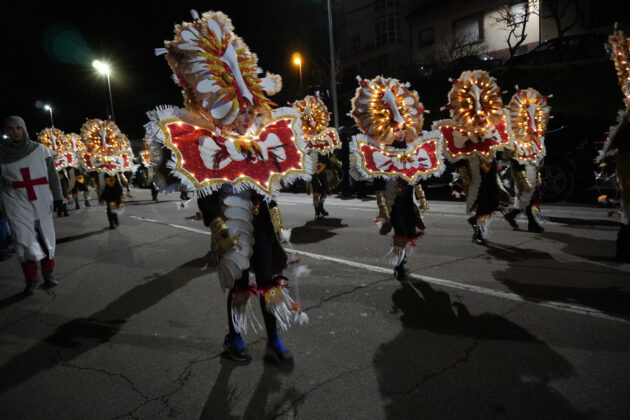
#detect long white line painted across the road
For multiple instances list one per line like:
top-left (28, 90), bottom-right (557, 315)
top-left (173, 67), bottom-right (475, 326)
top-left (130, 216), bottom-right (630, 324)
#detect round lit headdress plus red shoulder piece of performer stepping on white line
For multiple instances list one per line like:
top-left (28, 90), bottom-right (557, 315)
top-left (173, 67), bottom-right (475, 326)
top-left (350, 76), bottom-right (444, 183)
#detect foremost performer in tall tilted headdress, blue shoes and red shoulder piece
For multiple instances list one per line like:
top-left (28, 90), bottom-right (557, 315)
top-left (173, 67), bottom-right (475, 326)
top-left (145, 11), bottom-right (311, 363)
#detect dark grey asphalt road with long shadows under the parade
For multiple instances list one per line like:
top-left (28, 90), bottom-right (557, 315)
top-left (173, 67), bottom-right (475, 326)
top-left (0, 190), bottom-right (630, 419)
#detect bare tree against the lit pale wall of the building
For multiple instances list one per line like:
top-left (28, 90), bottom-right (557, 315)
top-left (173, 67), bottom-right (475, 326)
top-left (494, 0), bottom-right (537, 67)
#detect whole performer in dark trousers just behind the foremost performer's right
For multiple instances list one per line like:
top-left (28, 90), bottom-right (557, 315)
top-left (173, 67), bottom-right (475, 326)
top-left (292, 95), bottom-right (341, 219)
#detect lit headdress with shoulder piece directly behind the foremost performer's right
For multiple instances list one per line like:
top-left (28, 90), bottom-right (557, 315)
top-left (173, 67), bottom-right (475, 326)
top-left (291, 95), bottom-right (341, 154)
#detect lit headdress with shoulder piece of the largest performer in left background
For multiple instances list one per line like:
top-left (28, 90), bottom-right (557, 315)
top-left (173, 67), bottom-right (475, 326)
top-left (81, 119), bottom-right (133, 174)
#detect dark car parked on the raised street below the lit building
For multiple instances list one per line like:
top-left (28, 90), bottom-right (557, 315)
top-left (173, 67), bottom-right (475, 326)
top-left (513, 34), bottom-right (608, 65)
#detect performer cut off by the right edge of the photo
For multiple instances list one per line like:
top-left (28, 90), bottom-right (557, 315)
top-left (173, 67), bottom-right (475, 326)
top-left (595, 30), bottom-right (630, 262)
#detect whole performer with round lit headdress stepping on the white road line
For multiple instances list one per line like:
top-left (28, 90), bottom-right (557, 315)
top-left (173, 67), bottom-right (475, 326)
top-left (350, 76), bottom-right (445, 280)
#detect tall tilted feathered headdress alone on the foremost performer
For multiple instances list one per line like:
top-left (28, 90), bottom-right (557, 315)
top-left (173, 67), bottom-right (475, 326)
top-left (156, 10), bottom-right (282, 127)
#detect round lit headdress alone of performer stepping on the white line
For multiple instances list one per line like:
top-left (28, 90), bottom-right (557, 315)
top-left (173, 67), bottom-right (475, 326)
top-left (351, 76), bottom-right (425, 145)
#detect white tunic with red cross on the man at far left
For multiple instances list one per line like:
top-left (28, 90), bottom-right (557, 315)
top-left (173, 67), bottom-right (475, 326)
top-left (0, 144), bottom-right (55, 261)
